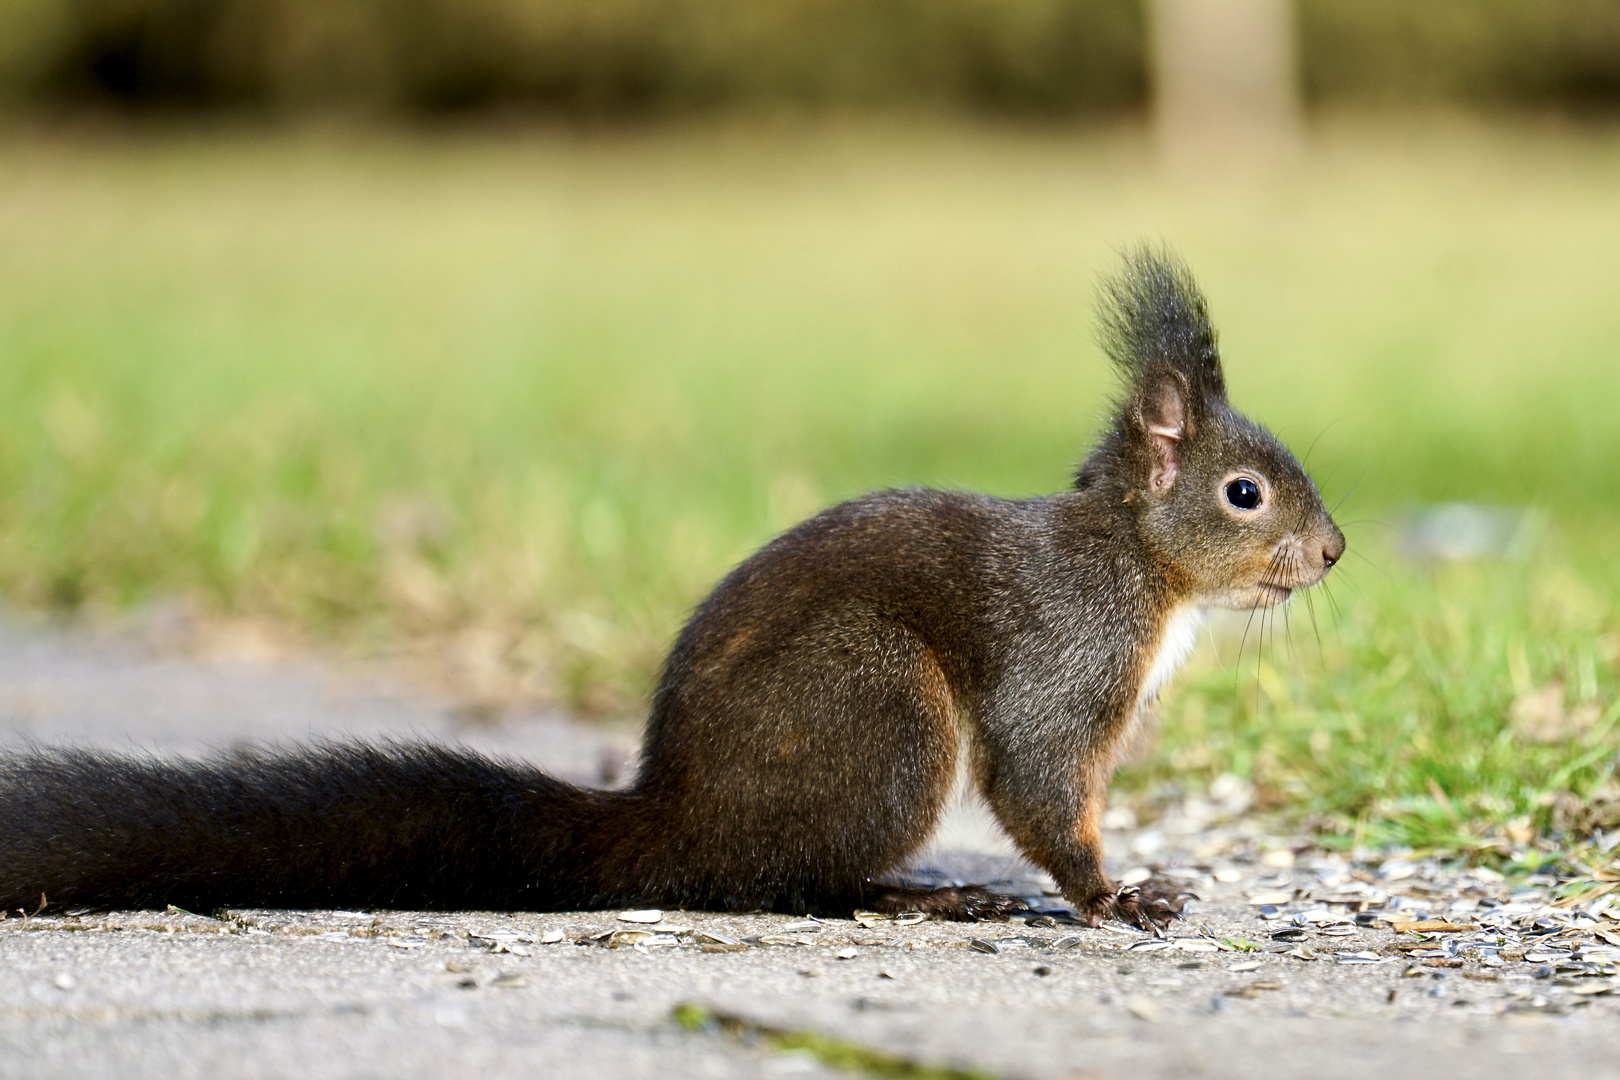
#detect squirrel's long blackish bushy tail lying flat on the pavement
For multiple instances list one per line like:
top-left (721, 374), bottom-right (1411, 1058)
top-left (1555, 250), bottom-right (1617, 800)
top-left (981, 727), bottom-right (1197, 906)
top-left (0, 743), bottom-right (632, 912)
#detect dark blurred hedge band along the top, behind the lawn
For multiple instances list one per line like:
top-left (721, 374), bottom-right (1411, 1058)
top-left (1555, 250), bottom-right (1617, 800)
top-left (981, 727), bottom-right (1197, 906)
top-left (0, 0), bottom-right (1620, 113)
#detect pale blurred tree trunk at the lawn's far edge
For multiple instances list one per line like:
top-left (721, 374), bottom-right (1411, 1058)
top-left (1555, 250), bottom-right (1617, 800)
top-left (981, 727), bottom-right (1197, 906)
top-left (1149, 0), bottom-right (1301, 165)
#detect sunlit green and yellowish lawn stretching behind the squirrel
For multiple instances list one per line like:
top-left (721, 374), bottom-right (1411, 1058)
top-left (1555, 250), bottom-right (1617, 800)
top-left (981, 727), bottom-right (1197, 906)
top-left (0, 120), bottom-right (1620, 867)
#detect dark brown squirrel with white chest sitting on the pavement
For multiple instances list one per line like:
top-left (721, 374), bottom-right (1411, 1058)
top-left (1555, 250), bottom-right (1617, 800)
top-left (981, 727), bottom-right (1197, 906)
top-left (0, 249), bottom-right (1345, 926)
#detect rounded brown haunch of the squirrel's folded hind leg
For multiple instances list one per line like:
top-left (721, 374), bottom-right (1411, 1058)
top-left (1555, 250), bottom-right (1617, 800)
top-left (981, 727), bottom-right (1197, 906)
top-left (625, 610), bottom-right (959, 918)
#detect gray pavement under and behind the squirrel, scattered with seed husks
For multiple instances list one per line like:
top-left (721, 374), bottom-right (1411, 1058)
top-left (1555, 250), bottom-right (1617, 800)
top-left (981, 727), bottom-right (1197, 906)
top-left (0, 628), bottom-right (1620, 1080)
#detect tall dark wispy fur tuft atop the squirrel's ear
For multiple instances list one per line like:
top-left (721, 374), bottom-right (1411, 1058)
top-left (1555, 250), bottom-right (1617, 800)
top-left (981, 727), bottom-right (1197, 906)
top-left (1098, 246), bottom-right (1226, 414)
